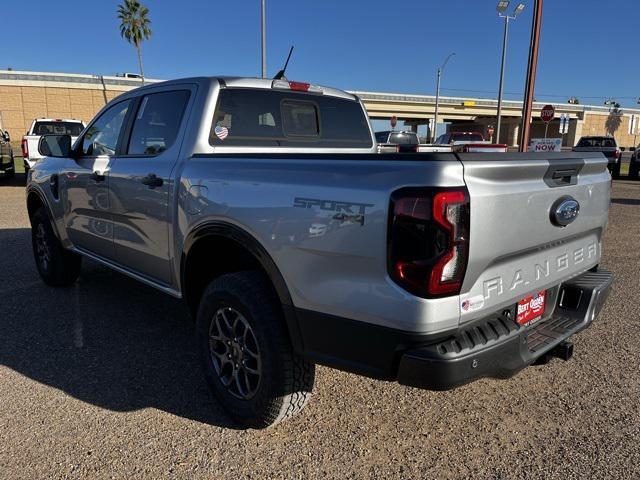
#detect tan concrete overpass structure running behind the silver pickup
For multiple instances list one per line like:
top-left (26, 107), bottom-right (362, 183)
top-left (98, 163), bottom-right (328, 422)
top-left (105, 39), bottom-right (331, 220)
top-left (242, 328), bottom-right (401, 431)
top-left (0, 70), bottom-right (640, 147)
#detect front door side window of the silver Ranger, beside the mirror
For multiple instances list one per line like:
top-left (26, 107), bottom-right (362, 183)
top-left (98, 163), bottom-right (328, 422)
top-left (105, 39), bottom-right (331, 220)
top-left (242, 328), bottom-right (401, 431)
top-left (82, 100), bottom-right (131, 157)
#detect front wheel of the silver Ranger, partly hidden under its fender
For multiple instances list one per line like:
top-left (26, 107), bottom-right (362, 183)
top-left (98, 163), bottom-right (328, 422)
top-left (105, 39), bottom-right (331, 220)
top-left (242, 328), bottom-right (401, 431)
top-left (31, 208), bottom-right (82, 287)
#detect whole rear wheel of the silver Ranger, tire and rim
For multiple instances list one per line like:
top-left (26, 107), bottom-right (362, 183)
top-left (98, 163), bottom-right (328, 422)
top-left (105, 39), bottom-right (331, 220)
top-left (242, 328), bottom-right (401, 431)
top-left (196, 271), bottom-right (315, 428)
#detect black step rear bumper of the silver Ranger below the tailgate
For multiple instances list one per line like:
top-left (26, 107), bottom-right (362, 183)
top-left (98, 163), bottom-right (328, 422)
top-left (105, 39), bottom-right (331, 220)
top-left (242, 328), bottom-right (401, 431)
top-left (397, 269), bottom-right (613, 390)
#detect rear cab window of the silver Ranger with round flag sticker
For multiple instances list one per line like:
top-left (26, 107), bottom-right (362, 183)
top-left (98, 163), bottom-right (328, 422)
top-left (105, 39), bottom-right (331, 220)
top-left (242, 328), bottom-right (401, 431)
top-left (209, 88), bottom-right (373, 148)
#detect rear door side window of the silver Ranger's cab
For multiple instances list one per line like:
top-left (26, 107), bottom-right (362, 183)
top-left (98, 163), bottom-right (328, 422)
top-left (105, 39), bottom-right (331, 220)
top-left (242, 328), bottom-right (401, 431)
top-left (127, 90), bottom-right (190, 155)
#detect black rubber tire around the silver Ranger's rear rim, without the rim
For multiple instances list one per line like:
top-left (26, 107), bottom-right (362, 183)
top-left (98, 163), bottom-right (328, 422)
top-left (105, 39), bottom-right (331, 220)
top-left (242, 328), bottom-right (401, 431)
top-left (196, 271), bottom-right (315, 428)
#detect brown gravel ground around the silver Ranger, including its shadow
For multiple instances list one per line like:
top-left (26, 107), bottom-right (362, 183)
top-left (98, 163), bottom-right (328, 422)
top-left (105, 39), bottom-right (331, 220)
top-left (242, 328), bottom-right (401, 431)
top-left (0, 176), bottom-right (640, 479)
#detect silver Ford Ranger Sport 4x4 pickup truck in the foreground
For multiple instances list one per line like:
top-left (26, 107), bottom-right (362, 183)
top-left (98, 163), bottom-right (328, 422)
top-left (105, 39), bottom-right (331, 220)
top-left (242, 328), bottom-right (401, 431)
top-left (27, 78), bottom-right (613, 428)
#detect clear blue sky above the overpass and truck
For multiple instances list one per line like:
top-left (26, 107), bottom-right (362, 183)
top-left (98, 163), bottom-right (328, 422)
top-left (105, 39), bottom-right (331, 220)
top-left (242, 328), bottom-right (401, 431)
top-left (0, 0), bottom-right (640, 106)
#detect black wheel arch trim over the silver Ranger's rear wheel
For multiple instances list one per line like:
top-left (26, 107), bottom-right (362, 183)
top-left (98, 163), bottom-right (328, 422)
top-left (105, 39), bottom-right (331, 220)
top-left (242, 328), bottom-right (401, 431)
top-left (180, 220), bottom-right (304, 353)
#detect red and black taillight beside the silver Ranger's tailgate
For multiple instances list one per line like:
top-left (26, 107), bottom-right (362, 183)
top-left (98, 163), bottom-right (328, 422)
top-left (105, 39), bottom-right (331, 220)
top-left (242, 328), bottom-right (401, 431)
top-left (388, 189), bottom-right (470, 297)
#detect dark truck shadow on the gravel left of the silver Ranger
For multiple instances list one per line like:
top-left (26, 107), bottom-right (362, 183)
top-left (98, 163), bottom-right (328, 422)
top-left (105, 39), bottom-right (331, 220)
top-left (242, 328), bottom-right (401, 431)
top-left (0, 229), bottom-right (234, 428)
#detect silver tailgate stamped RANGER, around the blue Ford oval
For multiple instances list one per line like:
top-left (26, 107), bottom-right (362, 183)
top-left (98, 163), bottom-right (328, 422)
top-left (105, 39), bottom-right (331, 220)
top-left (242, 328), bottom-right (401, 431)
top-left (458, 152), bottom-right (611, 323)
